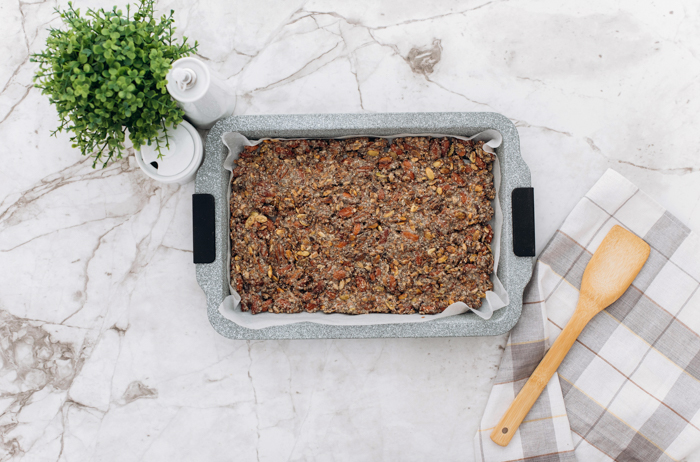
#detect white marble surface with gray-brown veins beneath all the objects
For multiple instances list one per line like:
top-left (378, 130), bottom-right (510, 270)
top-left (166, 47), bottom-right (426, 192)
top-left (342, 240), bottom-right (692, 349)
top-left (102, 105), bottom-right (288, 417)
top-left (0, 0), bottom-right (700, 461)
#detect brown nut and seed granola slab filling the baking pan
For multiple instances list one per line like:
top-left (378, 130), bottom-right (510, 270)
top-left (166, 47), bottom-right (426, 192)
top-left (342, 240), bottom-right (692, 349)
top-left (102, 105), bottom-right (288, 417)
top-left (230, 137), bottom-right (496, 314)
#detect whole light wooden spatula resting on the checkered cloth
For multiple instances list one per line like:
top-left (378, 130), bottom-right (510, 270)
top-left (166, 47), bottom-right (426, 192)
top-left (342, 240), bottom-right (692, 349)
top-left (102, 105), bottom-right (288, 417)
top-left (491, 225), bottom-right (649, 446)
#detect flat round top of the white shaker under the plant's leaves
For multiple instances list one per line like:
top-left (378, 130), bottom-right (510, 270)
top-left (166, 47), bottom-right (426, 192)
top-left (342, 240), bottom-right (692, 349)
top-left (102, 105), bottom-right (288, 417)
top-left (140, 121), bottom-right (199, 177)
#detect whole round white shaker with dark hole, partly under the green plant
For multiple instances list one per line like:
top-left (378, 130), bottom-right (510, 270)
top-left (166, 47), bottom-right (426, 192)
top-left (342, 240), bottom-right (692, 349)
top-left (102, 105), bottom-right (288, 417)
top-left (136, 120), bottom-right (204, 184)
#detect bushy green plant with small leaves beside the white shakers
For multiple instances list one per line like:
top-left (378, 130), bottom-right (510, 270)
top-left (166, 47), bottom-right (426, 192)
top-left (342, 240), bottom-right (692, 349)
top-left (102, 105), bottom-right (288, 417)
top-left (32, 0), bottom-right (197, 168)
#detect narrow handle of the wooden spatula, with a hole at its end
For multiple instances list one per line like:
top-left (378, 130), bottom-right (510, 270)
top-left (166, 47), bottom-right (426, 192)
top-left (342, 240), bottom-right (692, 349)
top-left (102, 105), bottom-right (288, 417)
top-left (491, 310), bottom-right (590, 446)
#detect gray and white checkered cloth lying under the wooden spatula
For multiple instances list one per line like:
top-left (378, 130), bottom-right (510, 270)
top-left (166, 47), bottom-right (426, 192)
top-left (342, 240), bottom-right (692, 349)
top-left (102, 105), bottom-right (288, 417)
top-left (474, 170), bottom-right (700, 462)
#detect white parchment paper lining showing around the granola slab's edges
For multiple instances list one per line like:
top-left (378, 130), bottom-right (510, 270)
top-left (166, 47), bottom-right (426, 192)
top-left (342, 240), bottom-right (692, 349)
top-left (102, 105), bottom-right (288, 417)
top-left (219, 130), bottom-right (508, 329)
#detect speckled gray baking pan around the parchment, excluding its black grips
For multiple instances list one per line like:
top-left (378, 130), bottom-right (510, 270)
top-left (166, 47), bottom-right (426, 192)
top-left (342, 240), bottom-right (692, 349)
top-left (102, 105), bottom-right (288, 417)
top-left (195, 112), bottom-right (534, 339)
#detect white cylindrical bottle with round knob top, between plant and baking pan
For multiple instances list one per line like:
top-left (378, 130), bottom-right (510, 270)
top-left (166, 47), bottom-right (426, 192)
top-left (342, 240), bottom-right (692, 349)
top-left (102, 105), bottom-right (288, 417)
top-left (167, 57), bottom-right (236, 130)
